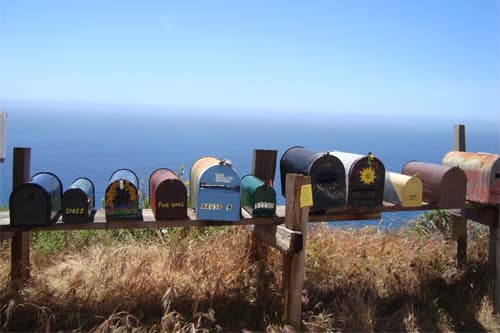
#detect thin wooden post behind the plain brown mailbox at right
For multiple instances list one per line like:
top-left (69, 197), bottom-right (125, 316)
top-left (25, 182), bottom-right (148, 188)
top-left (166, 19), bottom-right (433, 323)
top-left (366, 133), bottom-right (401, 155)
top-left (451, 125), bottom-right (467, 267)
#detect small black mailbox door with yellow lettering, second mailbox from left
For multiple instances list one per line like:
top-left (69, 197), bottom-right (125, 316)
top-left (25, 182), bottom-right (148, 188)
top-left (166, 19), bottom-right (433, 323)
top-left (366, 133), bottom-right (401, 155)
top-left (62, 188), bottom-right (92, 223)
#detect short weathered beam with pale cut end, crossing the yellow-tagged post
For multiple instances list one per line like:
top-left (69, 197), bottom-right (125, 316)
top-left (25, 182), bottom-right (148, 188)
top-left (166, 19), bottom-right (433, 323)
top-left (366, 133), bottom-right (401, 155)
top-left (251, 225), bottom-right (303, 254)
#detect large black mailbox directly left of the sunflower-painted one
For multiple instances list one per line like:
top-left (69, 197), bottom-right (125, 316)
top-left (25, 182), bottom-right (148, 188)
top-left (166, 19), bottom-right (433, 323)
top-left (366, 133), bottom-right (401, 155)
top-left (280, 146), bottom-right (346, 211)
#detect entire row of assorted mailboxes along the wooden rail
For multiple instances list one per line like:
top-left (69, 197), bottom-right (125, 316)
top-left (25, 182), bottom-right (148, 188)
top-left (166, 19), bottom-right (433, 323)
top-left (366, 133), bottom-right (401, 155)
top-left (9, 151), bottom-right (500, 226)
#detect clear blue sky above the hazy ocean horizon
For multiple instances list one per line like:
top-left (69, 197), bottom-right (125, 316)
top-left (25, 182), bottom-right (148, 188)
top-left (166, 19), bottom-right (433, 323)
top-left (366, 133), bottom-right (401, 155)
top-left (0, 0), bottom-right (500, 120)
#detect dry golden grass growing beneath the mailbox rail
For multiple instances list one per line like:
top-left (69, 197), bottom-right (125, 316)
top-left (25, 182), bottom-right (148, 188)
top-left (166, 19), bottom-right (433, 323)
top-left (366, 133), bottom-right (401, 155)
top-left (0, 227), bottom-right (500, 332)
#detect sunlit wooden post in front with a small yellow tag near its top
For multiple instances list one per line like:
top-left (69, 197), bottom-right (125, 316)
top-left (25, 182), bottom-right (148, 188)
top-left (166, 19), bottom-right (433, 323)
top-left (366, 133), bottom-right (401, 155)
top-left (283, 174), bottom-right (311, 330)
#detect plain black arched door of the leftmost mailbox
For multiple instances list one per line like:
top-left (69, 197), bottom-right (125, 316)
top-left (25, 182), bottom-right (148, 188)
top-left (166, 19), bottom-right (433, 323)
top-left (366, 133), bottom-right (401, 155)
top-left (9, 183), bottom-right (53, 226)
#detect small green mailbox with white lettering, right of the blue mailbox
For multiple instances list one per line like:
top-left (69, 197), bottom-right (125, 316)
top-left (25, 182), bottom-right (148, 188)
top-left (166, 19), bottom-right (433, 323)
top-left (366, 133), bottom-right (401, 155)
top-left (241, 175), bottom-right (276, 217)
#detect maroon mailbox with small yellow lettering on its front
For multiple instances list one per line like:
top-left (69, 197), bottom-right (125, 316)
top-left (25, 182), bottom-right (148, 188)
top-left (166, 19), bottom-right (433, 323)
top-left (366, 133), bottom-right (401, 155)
top-left (149, 168), bottom-right (187, 220)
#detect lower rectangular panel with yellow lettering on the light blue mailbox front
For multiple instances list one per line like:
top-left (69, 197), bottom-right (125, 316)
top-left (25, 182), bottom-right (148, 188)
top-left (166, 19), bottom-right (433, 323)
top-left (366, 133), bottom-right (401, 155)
top-left (196, 187), bottom-right (240, 221)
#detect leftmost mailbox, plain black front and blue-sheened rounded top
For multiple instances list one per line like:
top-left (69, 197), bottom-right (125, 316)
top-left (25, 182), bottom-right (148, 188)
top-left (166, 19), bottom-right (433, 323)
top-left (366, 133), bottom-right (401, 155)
top-left (9, 172), bottom-right (62, 226)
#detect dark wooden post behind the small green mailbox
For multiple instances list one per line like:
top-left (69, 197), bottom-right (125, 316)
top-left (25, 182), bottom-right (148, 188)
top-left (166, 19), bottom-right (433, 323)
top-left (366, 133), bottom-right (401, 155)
top-left (250, 149), bottom-right (278, 309)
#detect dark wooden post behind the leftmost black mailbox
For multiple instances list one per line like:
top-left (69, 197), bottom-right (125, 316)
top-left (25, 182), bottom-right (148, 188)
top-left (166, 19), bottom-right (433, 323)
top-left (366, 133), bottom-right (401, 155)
top-left (10, 148), bottom-right (31, 287)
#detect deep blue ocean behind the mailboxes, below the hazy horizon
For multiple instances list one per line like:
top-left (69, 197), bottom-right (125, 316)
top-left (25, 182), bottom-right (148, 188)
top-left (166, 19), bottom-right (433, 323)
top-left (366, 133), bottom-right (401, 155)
top-left (0, 104), bottom-right (500, 226)
